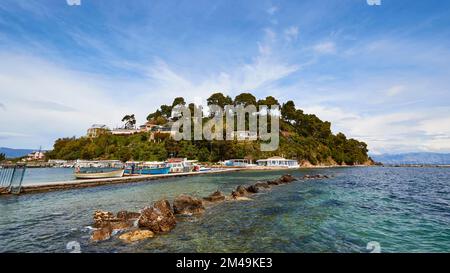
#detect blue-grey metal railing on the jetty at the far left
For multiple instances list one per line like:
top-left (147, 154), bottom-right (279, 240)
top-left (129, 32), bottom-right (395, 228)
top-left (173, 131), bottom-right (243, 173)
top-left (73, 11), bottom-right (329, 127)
top-left (0, 164), bottom-right (26, 194)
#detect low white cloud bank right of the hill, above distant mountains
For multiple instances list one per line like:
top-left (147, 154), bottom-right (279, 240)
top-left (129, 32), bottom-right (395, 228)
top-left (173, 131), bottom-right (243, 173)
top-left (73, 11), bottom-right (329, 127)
top-left (303, 105), bottom-right (450, 154)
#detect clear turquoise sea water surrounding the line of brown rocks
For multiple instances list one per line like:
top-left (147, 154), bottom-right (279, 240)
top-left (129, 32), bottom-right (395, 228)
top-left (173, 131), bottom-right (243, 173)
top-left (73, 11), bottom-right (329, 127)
top-left (0, 167), bottom-right (450, 252)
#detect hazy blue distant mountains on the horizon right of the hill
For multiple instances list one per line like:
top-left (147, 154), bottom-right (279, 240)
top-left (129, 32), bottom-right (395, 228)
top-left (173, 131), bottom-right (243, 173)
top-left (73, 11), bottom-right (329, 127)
top-left (371, 152), bottom-right (450, 165)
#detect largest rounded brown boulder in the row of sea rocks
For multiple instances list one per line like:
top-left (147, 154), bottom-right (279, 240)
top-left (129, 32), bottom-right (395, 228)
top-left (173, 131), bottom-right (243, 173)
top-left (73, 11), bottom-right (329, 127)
top-left (138, 200), bottom-right (177, 233)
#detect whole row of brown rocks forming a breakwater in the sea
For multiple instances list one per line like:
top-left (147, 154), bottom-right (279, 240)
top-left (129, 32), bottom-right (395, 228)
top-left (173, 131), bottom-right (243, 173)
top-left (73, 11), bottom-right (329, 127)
top-left (91, 174), bottom-right (329, 243)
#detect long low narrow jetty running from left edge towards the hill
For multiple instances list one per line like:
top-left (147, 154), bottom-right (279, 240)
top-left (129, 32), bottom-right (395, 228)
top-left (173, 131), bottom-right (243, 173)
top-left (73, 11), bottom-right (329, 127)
top-left (0, 168), bottom-right (244, 195)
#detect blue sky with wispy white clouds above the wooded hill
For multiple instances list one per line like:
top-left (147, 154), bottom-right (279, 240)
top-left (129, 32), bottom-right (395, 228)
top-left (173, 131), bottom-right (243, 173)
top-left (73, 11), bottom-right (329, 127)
top-left (0, 0), bottom-right (450, 153)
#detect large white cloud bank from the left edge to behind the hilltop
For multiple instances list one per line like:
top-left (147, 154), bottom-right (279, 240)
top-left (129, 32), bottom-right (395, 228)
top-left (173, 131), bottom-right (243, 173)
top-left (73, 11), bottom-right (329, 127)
top-left (0, 29), bottom-right (298, 149)
